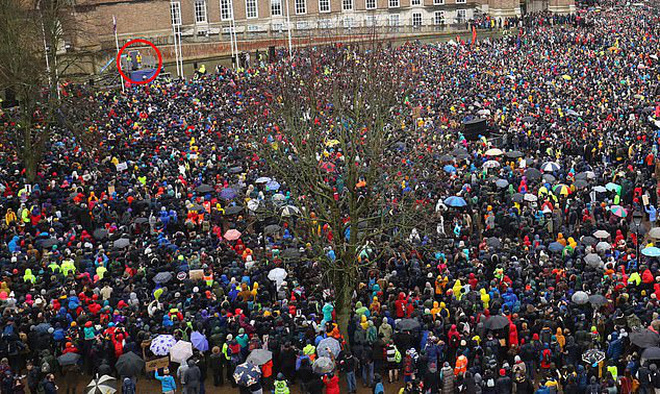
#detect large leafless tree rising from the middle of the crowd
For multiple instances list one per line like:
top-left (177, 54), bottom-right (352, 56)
top-left (261, 47), bottom-right (432, 342)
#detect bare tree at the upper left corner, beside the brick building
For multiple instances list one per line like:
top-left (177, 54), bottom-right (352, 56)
top-left (0, 0), bottom-right (94, 182)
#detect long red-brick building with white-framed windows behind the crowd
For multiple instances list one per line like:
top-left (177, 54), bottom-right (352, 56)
top-left (76, 0), bottom-right (574, 74)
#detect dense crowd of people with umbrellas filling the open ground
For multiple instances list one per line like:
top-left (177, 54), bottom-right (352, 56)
top-left (0, 2), bottom-right (660, 394)
